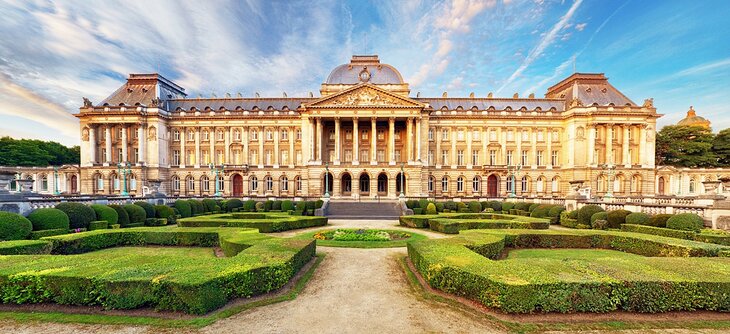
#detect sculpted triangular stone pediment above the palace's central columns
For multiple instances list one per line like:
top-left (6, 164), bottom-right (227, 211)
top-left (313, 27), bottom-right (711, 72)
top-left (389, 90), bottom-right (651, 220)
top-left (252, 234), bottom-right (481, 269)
top-left (306, 84), bottom-right (424, 108)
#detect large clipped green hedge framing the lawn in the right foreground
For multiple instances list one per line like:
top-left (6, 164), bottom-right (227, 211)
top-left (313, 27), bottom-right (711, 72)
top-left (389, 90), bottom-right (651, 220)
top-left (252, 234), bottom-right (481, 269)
top-left (408, 230), bottom-right (730, 313)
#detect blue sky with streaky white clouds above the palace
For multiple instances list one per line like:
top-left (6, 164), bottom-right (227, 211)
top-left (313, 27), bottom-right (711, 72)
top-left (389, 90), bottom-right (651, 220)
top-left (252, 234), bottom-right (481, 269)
top-left (0, 0), bottom-right (730, 145)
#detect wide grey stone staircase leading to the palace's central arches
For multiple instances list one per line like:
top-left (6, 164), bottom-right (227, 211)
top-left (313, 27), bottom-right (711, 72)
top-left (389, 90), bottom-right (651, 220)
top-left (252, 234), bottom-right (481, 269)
top-left (327, 200), bottom-right (401, 220)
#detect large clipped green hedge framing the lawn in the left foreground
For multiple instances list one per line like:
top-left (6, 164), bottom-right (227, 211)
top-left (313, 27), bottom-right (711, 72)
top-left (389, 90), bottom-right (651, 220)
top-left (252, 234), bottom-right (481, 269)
top-left (0, 228), bottom-right (316, 314)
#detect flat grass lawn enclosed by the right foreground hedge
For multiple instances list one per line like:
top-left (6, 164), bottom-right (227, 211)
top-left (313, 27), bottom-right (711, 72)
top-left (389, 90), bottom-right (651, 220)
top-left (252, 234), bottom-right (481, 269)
top-left (506, 248), bottom-right (643, 260)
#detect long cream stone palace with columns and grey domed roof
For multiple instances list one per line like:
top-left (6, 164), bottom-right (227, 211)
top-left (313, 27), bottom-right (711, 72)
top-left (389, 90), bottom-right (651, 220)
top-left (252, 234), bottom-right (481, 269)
top-left (76, 56), bottom-right (661, 199)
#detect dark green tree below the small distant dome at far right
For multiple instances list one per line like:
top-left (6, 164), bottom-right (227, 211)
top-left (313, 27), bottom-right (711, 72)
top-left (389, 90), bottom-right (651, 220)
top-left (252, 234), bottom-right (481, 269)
top-left (656, 125), bottom-right (717, 167)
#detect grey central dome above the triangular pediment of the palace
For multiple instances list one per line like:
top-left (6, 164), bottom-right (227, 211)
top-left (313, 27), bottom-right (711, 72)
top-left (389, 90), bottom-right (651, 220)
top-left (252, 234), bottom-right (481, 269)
top-left (325, 56), bottom-right (403, 85)
